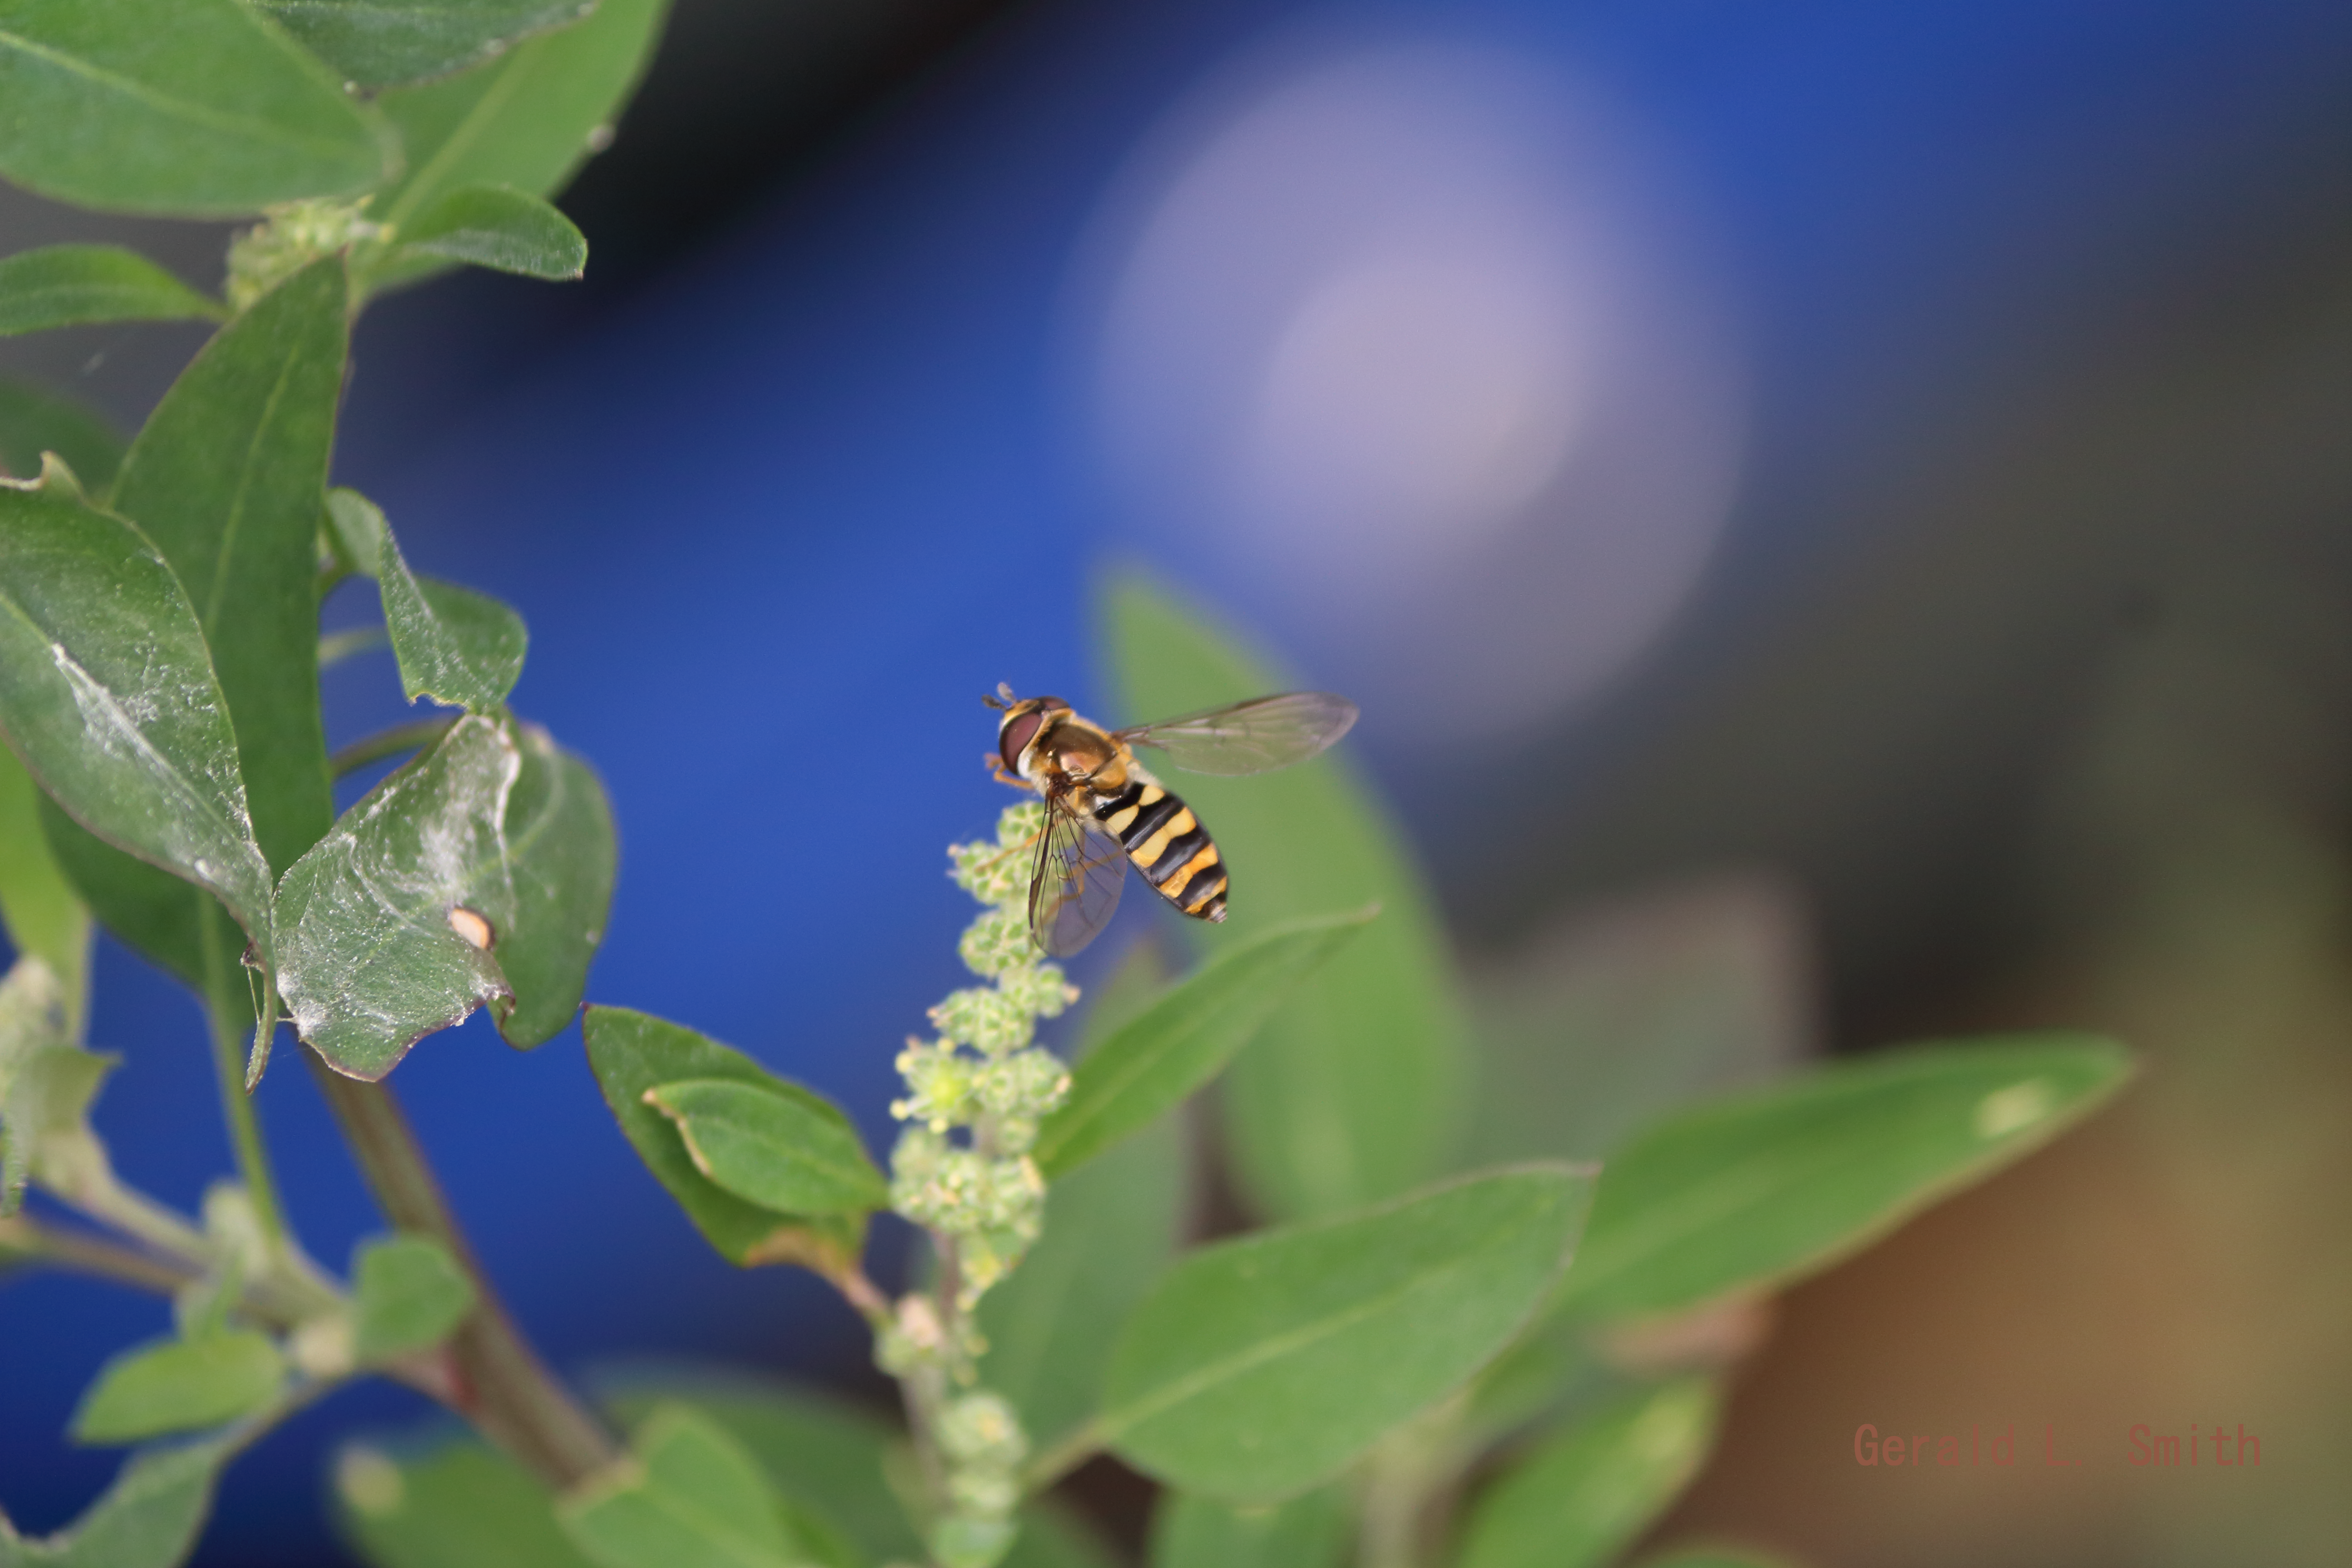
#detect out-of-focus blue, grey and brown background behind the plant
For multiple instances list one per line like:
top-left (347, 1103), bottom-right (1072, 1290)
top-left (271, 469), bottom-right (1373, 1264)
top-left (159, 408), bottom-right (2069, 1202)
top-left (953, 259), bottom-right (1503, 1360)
top-left (0, 0), bottom-right (2352, 1563)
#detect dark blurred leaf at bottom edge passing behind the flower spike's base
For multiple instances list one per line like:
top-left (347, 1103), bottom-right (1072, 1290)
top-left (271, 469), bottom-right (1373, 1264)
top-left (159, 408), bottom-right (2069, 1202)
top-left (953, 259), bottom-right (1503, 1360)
top-left (614, 1382), bottom-right (1115, 1568)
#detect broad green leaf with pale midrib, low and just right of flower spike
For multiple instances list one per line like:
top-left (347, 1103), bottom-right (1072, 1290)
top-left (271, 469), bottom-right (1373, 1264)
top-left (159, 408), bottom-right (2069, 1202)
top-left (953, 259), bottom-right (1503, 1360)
top-left (1098, 1166), bottom-right (1592, 1502)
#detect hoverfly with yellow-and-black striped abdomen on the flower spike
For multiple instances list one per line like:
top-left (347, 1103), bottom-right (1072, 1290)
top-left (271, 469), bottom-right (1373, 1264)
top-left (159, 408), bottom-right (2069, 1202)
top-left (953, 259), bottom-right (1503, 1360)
top-left (981, 684), bottom-right (1355, 959)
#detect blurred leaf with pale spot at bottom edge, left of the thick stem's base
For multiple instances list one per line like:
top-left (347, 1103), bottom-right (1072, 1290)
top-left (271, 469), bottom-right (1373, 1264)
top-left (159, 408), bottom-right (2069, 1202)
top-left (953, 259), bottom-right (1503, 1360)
top-left (334, 1441), bottom-right (588, 1568)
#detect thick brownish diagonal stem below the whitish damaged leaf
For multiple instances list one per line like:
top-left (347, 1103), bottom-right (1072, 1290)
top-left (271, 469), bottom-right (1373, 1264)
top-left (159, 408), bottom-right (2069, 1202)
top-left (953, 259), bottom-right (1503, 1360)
top-left (304, 1053), bottom-right (621, 1490)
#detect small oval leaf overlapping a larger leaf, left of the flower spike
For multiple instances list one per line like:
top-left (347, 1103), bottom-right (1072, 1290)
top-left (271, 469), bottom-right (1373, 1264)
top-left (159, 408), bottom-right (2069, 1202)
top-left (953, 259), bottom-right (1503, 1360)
top-left (644, 1079), bottom-right (889, 1213)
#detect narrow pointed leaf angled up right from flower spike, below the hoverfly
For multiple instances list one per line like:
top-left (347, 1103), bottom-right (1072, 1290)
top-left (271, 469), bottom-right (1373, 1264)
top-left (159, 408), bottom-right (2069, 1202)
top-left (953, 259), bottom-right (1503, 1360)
top-left (1037, 910), bottom-right (1373, 1178)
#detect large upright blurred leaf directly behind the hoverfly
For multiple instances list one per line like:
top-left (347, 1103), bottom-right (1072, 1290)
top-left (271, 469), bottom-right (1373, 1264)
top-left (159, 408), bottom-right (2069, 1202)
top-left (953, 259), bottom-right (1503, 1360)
top-left (1105, 581), bottom-right (1470, 1218)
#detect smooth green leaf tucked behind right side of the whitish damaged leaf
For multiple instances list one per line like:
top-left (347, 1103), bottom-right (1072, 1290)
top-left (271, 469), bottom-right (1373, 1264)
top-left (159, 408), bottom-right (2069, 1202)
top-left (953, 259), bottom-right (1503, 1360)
top-left (489, 724), bottom-right (618, 1051)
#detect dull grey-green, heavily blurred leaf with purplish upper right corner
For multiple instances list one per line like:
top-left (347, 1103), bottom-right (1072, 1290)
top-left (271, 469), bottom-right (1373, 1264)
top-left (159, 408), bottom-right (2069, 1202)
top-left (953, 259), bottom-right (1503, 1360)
top-left (1463, 877), bottom-right (1816, 1159)
